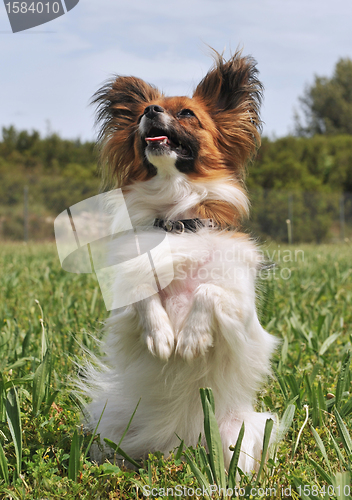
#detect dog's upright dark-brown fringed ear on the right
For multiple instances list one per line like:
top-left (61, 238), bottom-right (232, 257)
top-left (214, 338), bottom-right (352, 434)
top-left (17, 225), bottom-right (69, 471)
top-left (193, 51), bottom-right (263, 171)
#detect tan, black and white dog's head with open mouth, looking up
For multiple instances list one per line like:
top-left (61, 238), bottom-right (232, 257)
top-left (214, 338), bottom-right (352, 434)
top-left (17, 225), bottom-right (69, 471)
top-left (93, 53), bottom-right (262, 225)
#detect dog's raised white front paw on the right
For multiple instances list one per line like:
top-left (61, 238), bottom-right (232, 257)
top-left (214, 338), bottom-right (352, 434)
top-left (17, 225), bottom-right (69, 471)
top-left (176, 317), bottom-right (213, 361)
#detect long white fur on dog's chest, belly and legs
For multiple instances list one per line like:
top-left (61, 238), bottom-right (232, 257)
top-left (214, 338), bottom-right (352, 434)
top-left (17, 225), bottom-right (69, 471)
top-left (83, 152), bottom-right (276, 471)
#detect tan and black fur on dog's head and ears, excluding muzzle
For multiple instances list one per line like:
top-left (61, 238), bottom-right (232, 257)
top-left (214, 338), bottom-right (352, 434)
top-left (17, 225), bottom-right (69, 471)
top-left (93, 51), bottom-right (262, 191)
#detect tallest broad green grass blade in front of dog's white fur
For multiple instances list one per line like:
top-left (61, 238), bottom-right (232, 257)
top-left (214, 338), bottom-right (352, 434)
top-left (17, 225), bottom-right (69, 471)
top-left (200, 389), bottom-right (226, 489)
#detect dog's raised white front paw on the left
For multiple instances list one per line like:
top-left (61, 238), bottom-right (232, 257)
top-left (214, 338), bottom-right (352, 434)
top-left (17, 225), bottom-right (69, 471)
top-left (143, 313), bottom-right (175, 361)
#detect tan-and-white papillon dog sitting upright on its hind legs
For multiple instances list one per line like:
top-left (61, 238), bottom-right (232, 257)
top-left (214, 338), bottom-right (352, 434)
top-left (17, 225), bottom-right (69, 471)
top-left (84, 52), bottom-right (276, 472)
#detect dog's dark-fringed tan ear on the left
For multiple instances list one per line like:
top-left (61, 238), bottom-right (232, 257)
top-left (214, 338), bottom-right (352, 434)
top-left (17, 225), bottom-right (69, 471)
top-left (92, 76), bottom-right (161, 186)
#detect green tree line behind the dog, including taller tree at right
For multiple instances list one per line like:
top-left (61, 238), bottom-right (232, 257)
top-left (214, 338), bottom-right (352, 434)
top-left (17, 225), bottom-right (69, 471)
top-left (0, 59), bottom-right (352, 240)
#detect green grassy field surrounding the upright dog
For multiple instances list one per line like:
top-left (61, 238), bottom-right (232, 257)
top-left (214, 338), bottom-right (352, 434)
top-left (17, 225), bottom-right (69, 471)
top-left (0, 242), bottom-right (352, 500)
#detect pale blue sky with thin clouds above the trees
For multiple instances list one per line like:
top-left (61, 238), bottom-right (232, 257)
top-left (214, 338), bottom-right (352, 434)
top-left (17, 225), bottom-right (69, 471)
top-left (0, 0), bottom-right (352, 140)
